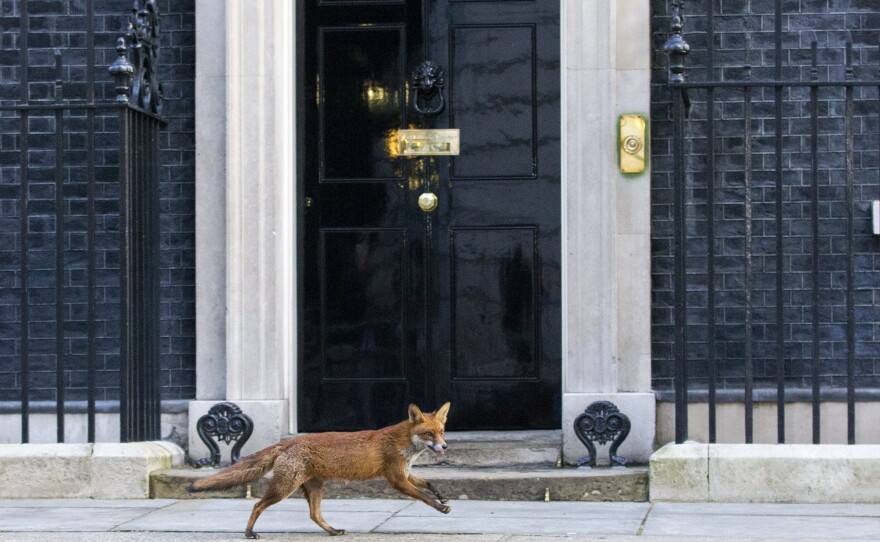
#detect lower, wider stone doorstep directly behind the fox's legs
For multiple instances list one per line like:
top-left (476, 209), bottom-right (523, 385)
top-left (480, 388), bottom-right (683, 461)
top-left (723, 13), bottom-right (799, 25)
top-left (150, 466), bottom-right (648, 502)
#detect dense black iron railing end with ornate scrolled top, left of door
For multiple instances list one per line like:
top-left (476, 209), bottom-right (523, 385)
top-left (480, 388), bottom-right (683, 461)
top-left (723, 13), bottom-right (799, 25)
top-left (110, 0), bottom-right (162, 442)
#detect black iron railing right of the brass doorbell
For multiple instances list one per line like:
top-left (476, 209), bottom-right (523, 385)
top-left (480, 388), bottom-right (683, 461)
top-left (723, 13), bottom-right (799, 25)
top-left (664, 0), bottom-right (880, 444)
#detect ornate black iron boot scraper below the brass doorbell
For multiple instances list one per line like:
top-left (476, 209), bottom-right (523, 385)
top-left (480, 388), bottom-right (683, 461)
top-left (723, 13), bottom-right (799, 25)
top-left (574, 401), bottom-right (630, 467)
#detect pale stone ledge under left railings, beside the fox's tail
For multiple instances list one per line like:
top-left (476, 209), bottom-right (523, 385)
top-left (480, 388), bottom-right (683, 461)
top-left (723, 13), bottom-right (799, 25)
top-left (0, 441), bottom-right (184, 499)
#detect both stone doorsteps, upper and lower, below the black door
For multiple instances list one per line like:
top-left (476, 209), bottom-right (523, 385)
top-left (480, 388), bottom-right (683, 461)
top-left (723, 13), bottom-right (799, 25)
top-left (160, 430), bottom-right (648, 502)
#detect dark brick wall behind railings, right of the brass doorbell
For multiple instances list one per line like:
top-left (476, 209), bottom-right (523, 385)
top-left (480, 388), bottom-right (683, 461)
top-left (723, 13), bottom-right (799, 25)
top-left (651, 0), bottom-right (880, 389)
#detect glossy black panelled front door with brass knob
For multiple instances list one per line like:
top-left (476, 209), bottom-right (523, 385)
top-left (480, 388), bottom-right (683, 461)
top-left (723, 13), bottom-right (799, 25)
top-left (298, 0), bottom-right (561, 431)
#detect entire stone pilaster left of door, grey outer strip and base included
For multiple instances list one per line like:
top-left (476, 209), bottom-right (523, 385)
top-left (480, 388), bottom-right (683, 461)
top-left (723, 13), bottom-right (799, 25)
top-left (190, 0), bottom-right (296, 456)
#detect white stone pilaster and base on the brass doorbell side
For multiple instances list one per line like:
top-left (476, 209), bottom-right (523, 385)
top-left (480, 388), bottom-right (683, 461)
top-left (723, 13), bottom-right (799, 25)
top-left (562, 0), bottom-right (655, 462)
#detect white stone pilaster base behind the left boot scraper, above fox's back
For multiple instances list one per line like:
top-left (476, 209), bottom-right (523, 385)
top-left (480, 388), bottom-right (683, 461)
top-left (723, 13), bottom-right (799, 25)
top-left (189, 400), bottom-right (288, 464)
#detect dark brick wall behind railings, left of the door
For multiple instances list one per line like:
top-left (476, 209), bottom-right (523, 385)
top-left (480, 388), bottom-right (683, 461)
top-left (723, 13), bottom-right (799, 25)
top-left (0, 0), bottom-right (195, 401)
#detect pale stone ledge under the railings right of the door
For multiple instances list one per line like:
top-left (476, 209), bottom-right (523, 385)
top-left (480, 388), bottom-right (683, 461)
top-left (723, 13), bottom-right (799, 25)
top-left (650, 442), bottom-right (880, 504)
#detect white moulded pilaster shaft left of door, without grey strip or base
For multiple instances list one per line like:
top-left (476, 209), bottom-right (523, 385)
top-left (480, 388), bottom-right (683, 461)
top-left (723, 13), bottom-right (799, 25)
top-left (226, 0), bottom-right (296, 401)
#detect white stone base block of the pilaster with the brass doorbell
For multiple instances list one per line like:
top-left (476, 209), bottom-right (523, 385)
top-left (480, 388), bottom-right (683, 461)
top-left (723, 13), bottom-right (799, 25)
top-left (562, 393), bottom-right (657, 465)
